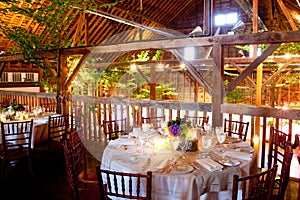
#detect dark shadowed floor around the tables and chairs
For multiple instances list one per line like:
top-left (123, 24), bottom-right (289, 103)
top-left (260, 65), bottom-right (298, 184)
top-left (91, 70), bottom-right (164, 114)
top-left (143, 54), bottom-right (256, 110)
top-left (0, 143), bottom-right (300, 200)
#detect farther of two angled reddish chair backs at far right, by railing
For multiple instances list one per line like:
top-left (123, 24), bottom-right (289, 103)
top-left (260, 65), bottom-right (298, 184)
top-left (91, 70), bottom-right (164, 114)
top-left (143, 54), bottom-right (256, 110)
top-left (268, 126), bottom-right (289, 168)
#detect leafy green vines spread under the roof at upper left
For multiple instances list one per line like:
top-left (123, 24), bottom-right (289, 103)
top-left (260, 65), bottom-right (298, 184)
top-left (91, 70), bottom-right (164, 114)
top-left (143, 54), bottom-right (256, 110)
top-left (0, 0), bottom-right (116, 64)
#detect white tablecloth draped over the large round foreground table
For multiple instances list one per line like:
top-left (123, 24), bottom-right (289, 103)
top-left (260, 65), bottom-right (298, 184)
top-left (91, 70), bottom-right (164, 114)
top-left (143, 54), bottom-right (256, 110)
top-left (101, 138), bottom-right (257, 200)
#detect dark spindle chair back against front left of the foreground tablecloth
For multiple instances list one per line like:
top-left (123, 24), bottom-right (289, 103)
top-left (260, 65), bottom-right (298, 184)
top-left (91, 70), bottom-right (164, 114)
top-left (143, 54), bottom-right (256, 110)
top-left (96, 166), bottom-right (152, 200)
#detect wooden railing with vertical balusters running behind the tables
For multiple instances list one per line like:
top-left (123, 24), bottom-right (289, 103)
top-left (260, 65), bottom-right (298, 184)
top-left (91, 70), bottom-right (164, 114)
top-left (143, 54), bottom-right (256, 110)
top-left (0, 91), bottom-right (300, 167)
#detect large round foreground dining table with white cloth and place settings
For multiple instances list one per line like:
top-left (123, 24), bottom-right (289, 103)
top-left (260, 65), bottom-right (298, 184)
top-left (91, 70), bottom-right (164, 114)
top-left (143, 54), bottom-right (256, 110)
top-left (101, 134), bottom-right (257, 200)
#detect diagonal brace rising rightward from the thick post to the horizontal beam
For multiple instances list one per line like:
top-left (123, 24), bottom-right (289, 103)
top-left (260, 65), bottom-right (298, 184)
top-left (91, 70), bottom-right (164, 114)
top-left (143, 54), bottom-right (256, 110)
top-left (225, 44), bottom-right (280, 95)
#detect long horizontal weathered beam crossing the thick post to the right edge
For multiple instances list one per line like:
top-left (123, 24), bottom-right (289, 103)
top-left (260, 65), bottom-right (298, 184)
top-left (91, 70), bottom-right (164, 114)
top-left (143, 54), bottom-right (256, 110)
top-left (61, 30), bottom-right (300, 55)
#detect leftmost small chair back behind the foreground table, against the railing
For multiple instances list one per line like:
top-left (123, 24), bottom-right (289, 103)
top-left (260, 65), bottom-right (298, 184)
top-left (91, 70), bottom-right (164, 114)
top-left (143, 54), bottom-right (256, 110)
top-left (102, 118), bottom-right (127, 140)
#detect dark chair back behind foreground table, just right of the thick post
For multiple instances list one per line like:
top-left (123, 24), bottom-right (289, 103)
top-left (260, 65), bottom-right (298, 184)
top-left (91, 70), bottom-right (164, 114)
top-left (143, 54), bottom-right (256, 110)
top-left (224, 118), bottom-right (249, 141)
